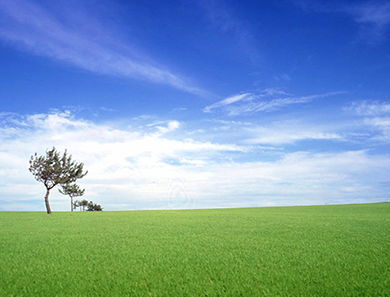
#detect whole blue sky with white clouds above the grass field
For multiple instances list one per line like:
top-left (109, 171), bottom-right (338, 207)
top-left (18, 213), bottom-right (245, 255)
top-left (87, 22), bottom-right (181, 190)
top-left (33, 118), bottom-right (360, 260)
top-left (0, 0), bottom-right (390, 211)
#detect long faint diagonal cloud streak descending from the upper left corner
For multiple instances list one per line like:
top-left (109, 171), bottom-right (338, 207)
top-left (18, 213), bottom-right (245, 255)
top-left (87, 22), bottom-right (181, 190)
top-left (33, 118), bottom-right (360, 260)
top-left (0, 0), bottom-right (207, 95)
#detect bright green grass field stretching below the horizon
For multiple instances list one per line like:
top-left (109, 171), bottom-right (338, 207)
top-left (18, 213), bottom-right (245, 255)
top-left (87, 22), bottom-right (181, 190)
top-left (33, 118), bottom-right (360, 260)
top-left (0, 203), bottom-right (390, 296)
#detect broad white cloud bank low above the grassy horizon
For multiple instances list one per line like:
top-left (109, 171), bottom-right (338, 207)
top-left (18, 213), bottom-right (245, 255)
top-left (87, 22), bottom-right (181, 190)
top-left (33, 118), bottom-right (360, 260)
top-left (0, 112), bottom-right (390, 211)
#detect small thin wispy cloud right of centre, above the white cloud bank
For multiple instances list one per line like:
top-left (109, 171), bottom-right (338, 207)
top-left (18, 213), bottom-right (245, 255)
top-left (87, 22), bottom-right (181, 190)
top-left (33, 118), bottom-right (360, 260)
top-left (203, 89), bottom-right (343, 116)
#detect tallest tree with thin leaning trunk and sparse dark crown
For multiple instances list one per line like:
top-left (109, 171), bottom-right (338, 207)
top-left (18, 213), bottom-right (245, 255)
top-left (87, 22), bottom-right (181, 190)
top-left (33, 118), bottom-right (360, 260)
top-left (29, 147), bottom-right (88, 214)
